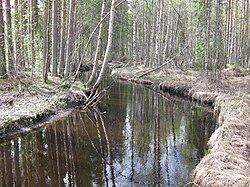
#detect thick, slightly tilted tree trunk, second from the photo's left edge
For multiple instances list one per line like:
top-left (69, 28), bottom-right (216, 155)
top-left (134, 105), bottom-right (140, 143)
top-left (5, 0), bottom-right (15, 76)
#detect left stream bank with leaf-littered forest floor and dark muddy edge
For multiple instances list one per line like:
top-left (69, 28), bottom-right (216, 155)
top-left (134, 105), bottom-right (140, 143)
top-left (0, 72), bottom-right (84, 140)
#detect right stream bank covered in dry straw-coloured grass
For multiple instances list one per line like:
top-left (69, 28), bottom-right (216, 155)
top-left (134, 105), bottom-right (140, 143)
top-left (112, 66), bottom-right (250, 187)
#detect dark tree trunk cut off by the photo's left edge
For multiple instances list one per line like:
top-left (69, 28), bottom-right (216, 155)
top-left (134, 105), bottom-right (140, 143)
top-left (0, 0), bottom-right (7, 77)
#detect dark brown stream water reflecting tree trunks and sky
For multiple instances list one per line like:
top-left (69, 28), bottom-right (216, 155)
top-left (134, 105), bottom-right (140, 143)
top-left (0, 84), bottom-right (215, 187)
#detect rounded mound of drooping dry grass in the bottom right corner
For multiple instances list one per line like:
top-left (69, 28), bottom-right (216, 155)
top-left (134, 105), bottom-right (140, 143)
top-left (194, 151), bottom-right (250, 187)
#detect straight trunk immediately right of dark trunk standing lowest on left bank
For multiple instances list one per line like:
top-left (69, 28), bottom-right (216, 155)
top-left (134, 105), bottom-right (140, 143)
top-left (51, 0), bottom-right (58, 76)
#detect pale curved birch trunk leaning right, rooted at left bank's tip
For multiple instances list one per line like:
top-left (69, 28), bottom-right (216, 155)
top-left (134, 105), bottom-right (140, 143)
top-left (93, 0), bottom-right (116, 90)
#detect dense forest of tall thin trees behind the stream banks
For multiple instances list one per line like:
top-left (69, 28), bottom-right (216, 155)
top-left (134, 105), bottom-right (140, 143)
top-left (0, 0), bottom-right (250, 81)
